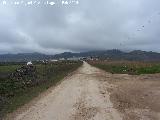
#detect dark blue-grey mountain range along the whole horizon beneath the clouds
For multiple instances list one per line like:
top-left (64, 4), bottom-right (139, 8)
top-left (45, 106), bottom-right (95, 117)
top-left (0, 49), bottom-right (160, 62)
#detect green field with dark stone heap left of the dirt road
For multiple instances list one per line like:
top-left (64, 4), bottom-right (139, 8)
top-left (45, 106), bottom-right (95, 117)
top-left (0, 61), bottom-right (82, 118)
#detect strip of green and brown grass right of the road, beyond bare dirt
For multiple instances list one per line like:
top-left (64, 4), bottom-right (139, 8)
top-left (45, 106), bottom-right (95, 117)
top-left (89, 61), bottom-right (160, 75)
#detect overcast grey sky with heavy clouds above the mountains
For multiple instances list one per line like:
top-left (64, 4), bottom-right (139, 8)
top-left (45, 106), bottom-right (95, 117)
top-left (0, 0), bottom-right (160, 54)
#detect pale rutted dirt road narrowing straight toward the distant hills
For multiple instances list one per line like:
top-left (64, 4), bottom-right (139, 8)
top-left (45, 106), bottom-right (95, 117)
top-left (7, 62), bottom-right (122, 120)
